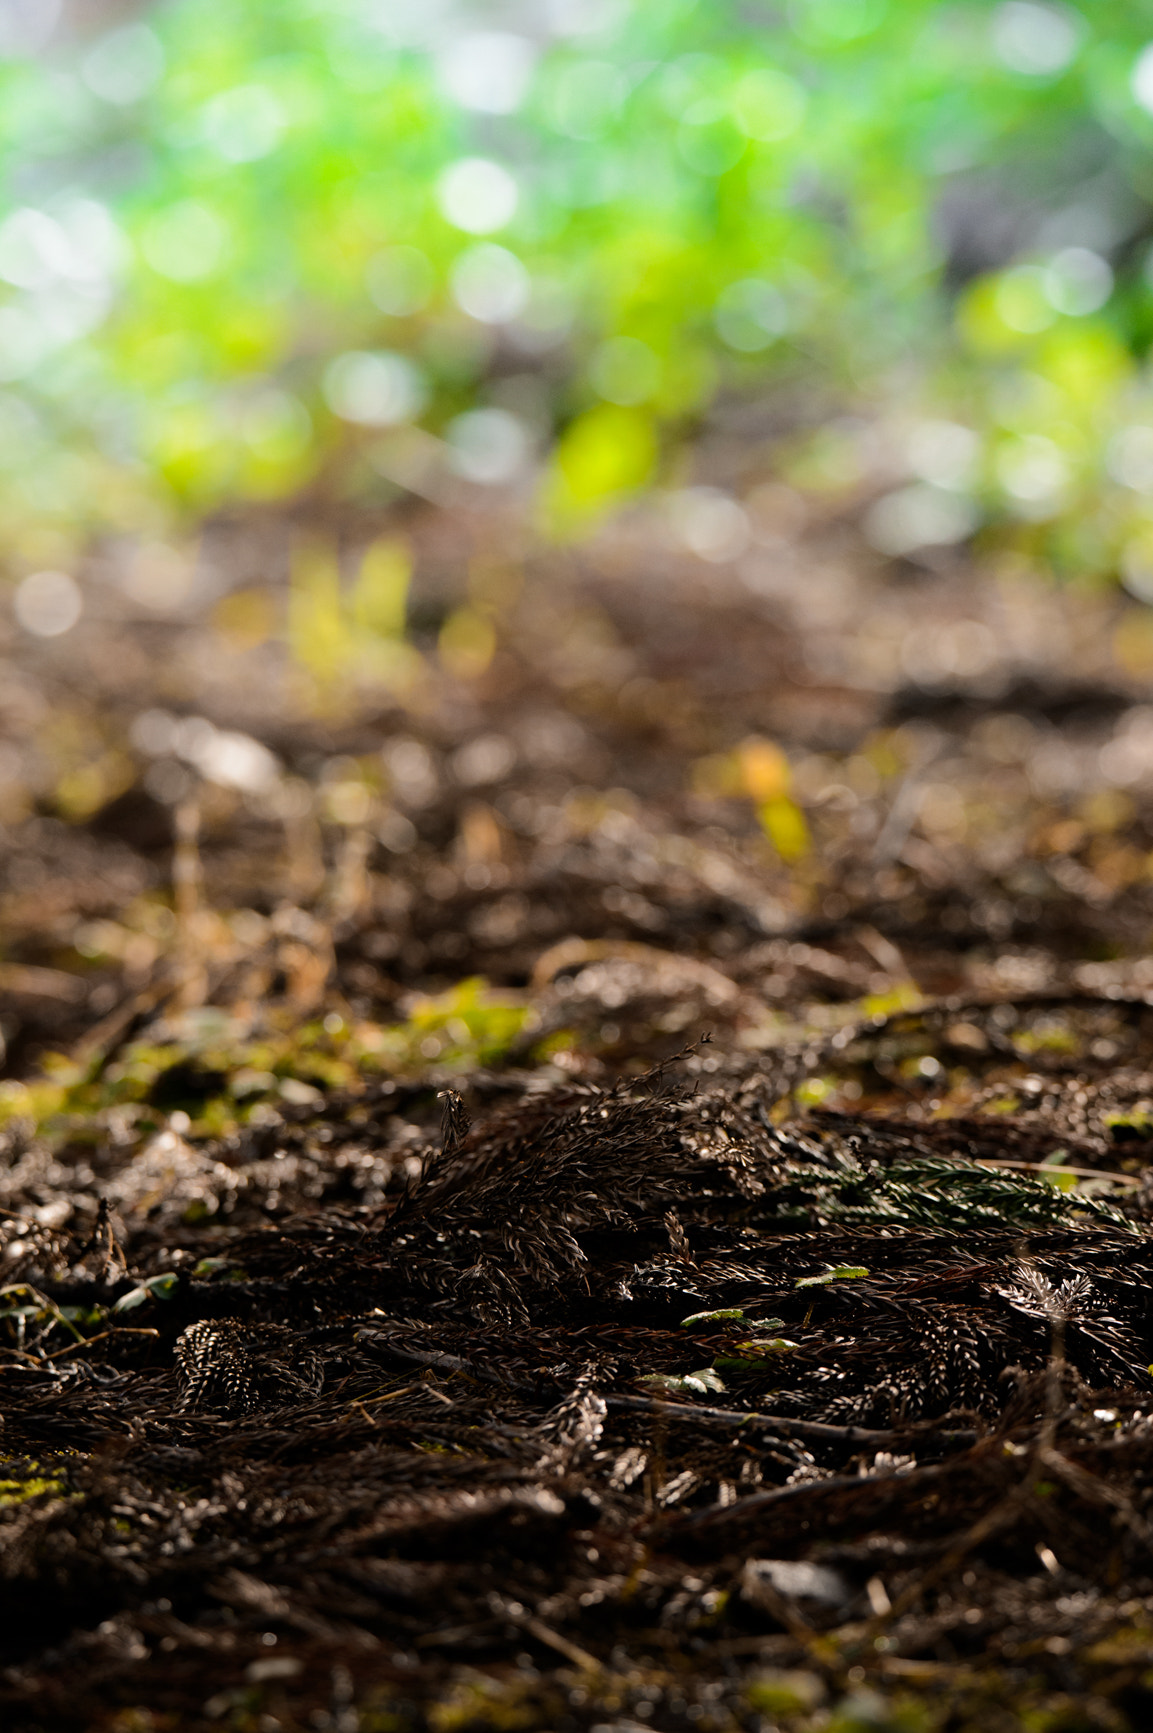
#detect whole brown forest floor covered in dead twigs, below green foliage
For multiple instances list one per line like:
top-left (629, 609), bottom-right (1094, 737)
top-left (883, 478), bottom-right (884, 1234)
top-left (0, 489), bottom-right (1153, 1733)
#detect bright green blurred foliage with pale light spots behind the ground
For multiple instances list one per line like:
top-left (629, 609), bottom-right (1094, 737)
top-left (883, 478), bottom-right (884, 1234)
top-left (0, 0), bottom-right (1153, 582)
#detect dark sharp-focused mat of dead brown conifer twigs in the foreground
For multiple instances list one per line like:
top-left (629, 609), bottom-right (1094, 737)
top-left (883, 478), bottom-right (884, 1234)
top-left (11, 1055), bottom-right (1153, 1726)
